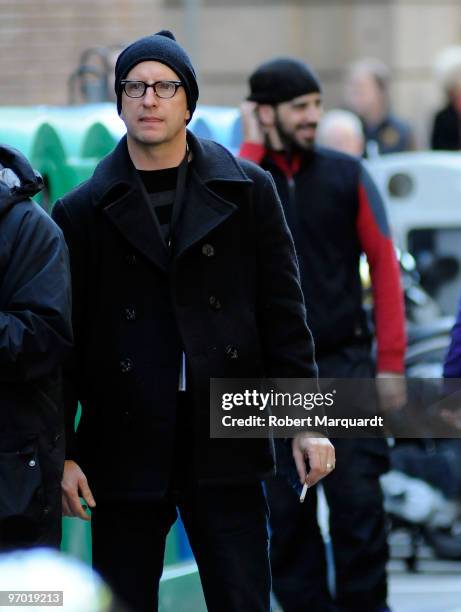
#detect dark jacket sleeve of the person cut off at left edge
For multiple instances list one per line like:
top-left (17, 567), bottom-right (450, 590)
top-left (0, 204), bottom-right (72, 382)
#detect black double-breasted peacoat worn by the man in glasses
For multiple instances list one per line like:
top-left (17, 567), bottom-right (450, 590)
top-left (53, 133), bottom-right (316, 499)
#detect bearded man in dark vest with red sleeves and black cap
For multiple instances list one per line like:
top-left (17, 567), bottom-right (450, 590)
top-left (240, 58), bottom-right (405, 612)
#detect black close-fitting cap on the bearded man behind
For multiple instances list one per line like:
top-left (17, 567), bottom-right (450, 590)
top-left (248, 57), bottom-right (322, 104)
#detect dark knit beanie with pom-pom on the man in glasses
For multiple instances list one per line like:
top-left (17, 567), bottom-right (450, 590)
top-left (115, 30), bottom-right (199, 117)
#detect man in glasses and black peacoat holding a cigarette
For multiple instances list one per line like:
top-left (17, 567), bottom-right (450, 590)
top-left (53, 31), bottom-right (334, 612)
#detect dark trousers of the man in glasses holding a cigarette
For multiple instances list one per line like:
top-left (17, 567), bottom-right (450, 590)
top-left (92, 483), bottom-right (271, 612)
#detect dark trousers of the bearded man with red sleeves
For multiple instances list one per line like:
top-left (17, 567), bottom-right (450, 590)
top-left (267, 345), bottom-right (388, 612)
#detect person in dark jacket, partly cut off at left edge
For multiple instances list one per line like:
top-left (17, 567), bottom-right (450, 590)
top-left (0, 146), bottom-right (72, 550)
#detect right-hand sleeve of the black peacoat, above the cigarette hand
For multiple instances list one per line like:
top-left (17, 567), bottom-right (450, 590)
top-left (255, 173), bottom-right (317, 378)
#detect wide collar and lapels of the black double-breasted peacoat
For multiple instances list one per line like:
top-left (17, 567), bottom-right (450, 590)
top-left (93, 132), bottom-right (253, 272)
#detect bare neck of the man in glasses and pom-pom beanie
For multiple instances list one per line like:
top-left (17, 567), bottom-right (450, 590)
top-left (127, 133), bottom-right (186, 170)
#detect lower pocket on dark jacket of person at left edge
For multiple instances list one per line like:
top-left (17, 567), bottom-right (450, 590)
top-left (0, 440), bottom-right (42, 520)
